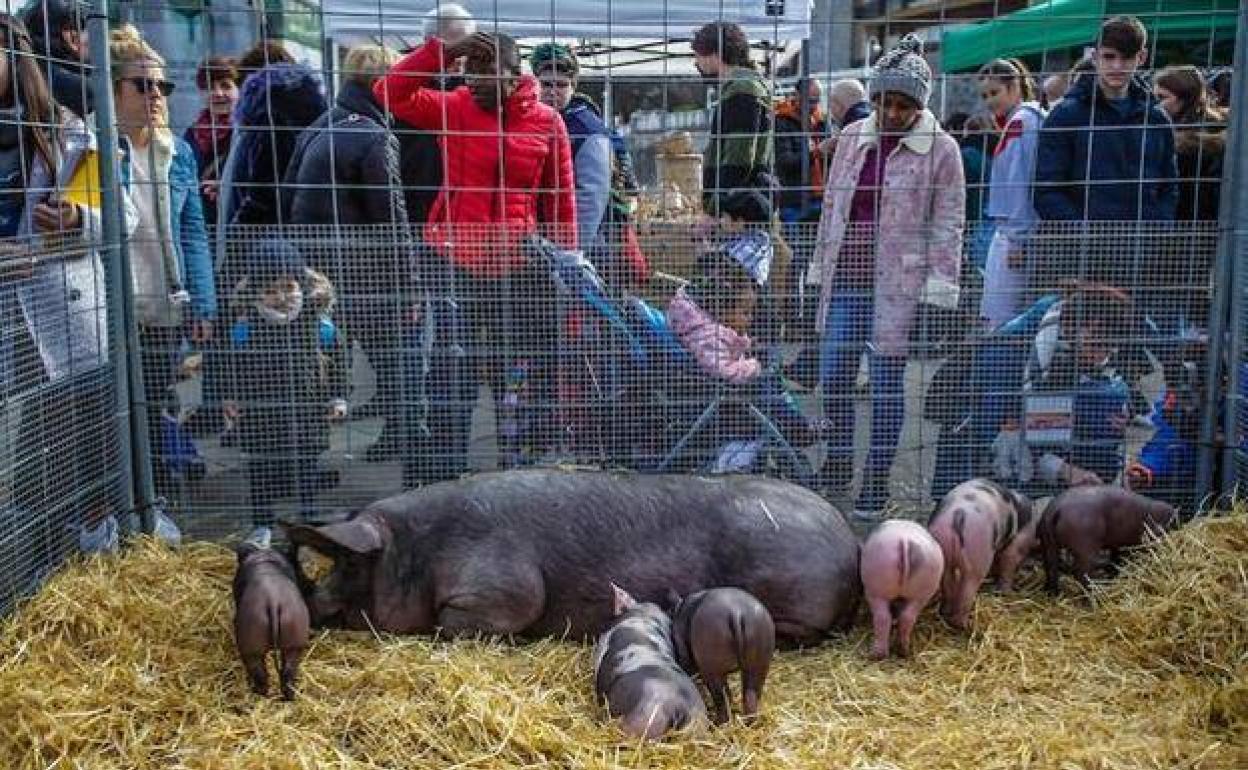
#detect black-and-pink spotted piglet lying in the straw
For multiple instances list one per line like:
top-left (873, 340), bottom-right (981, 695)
top-left (594, 583), bottom-right (706, 740)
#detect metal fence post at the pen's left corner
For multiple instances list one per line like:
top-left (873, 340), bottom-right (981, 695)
top-left (87, 0), bottom-right (154, 532)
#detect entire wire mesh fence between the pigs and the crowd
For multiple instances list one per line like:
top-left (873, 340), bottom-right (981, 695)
top-left (0, 0), bottom-right (1248, 602)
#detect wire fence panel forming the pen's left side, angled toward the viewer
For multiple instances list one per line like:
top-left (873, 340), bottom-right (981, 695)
top-left (0, 1), bottom-right (135, 614)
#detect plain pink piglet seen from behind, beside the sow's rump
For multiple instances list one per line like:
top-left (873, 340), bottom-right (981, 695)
top-left (860, 519), bottom-right (945, 660)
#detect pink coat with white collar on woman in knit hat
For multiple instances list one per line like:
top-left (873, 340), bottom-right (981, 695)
top-left (811, 110), bottom-right (966, 356)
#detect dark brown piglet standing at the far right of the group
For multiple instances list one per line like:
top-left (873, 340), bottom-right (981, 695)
top-left (1040, 484), bottom-right (1178, 594)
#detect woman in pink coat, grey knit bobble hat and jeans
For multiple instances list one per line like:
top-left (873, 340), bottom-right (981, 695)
top-left (811, 35), bottom-right (966, 520)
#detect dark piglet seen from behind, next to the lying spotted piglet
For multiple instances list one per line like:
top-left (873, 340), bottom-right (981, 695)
top-left (671, 588), bottom-right (776, 724)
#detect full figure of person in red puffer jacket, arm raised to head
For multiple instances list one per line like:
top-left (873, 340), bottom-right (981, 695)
top-left (373, 32), bottom-right (577, 487)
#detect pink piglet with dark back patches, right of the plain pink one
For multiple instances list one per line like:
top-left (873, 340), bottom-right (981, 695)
top-left (927, 478), bottom-right (1040, 630)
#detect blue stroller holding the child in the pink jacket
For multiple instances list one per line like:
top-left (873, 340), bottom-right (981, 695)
top-left (529, 239), bottom-right (814, 483)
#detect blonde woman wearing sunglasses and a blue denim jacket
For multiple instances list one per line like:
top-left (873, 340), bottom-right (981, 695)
top-left (109, 25), bottom-right (217, 493)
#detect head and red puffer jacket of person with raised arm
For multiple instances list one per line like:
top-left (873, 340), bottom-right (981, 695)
top-left (373, 32), bottom-right (577, 273)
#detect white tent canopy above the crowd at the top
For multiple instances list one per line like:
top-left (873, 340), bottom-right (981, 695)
top-left (321, 0), bottom-right (811, 42)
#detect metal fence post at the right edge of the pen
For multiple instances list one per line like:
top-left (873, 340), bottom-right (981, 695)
top-left (1197, 6), bottom-right (1248, 499)
